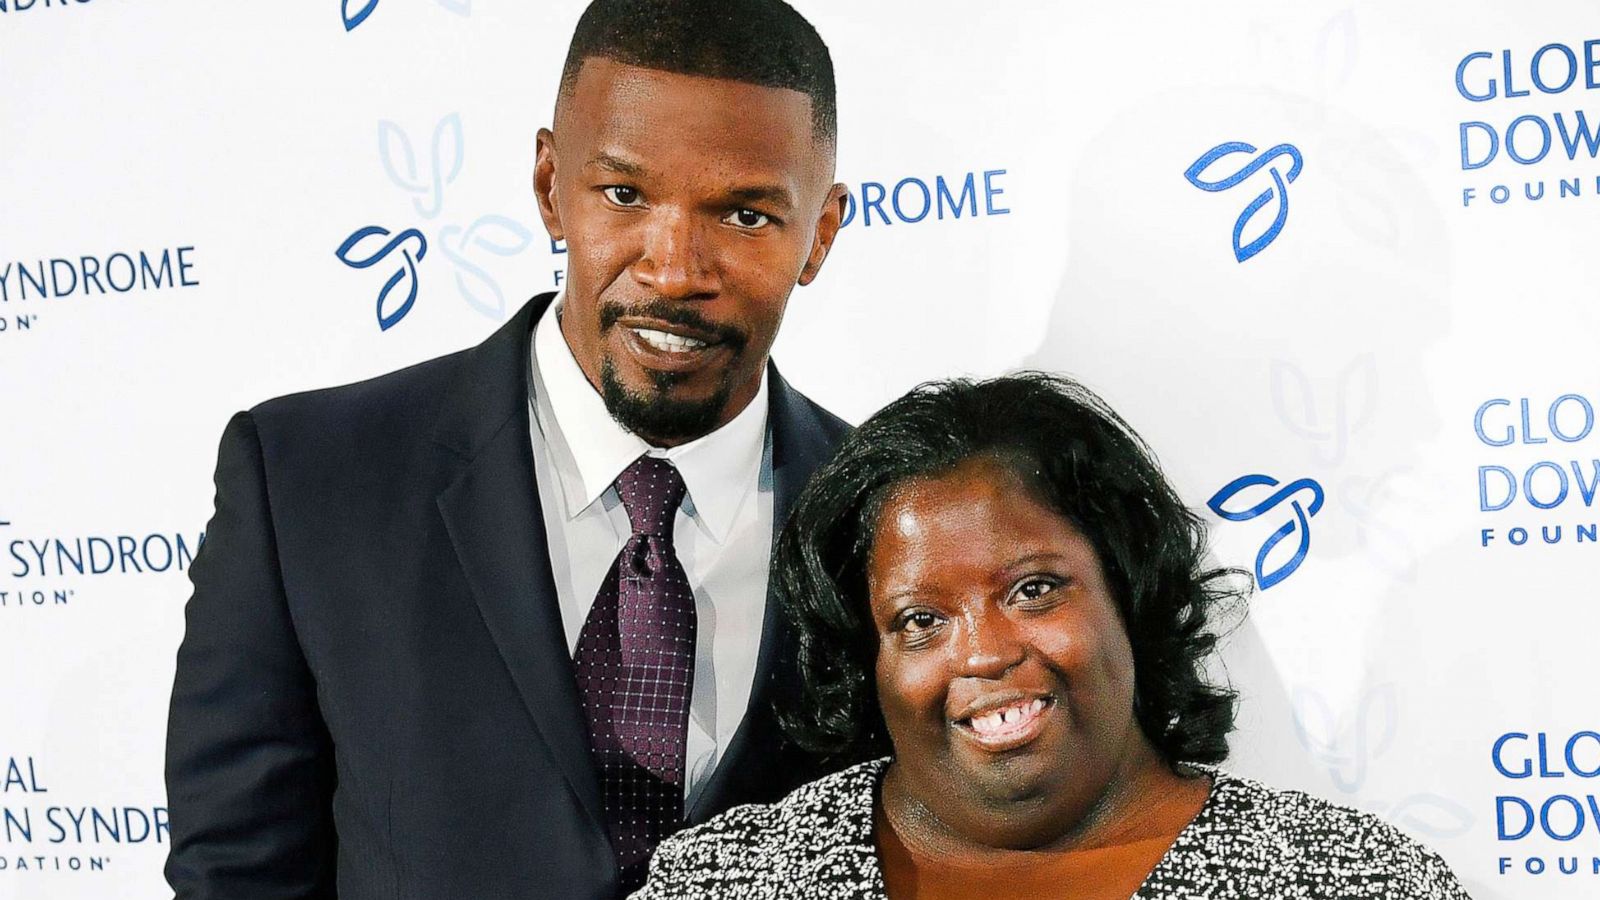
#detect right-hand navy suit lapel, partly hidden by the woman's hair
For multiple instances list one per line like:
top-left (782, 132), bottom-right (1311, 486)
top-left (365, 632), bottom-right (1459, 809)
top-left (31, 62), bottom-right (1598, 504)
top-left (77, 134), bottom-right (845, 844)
top-left (688, 362), bottom-right (834, 823)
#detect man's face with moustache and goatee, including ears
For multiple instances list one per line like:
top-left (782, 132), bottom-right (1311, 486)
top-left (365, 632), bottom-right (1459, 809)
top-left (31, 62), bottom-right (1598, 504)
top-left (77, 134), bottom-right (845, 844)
top-left (534, 58), bottom-right (845, 445)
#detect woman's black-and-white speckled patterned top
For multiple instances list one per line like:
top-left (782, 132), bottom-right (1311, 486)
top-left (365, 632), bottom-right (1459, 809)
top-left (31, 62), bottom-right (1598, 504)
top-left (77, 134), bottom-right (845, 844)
top-left (632, 759), bottom-right (1469, 900)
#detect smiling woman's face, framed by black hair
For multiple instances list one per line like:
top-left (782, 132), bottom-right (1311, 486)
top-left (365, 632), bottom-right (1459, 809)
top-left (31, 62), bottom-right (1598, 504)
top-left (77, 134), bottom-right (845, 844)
top-left (867, 456), bottom-right (1149, 849)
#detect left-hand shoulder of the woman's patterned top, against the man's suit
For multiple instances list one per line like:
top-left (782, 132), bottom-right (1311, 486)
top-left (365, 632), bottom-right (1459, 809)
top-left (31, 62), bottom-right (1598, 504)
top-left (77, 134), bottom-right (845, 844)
top-left (634, 759), bottom-right (888, 900)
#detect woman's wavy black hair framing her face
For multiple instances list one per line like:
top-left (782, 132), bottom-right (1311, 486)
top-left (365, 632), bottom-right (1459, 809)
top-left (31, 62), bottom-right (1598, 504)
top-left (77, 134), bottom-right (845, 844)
top-left (773, 372), bottom-right (1250, 767)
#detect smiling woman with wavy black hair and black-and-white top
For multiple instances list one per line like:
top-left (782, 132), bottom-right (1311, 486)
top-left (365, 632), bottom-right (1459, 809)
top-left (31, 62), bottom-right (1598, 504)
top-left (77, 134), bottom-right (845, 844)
top-left (635, 373), bottom-right (1466, 900)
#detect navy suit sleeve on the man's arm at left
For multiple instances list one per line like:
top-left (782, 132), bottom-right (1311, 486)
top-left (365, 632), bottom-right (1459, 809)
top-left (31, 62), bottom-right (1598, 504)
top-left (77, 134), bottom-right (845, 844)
top-left (166, 413), bottom-right (336, 900)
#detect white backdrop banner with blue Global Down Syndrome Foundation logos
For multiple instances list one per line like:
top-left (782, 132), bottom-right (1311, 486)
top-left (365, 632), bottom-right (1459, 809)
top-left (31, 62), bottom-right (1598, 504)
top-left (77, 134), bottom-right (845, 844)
top-left (0, 0), bottom-right (1600, 900)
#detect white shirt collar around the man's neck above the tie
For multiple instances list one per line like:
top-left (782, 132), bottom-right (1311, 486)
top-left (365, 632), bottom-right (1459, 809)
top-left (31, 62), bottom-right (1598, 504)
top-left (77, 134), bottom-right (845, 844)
top-left (531, 291), bottom-right (768, 543)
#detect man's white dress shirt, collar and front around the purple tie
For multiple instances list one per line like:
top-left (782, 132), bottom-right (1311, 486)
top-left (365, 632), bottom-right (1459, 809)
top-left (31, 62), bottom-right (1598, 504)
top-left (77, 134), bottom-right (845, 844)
top-left (530, 295), bottom-right (773, 809)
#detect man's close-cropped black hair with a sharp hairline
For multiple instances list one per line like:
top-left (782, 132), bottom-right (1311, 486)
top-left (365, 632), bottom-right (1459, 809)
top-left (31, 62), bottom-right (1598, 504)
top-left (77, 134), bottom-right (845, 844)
top-left (562, 0), bottom-right (838, 146)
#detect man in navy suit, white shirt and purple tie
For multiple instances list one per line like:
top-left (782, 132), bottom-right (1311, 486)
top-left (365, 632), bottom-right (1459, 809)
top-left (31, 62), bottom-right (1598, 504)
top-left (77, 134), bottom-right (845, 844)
top-left (166, 0), bottom-right (846, 900)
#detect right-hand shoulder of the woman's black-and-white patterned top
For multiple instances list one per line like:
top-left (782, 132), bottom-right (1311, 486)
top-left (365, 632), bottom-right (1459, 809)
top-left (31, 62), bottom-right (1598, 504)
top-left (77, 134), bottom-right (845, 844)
top-left (1158, 770), bottom-right (1467, 900)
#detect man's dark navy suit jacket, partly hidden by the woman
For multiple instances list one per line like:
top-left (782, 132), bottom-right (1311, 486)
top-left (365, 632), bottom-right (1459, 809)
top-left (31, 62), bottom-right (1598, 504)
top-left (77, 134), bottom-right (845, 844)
top-left (166, 295), bottom-right (848, 900)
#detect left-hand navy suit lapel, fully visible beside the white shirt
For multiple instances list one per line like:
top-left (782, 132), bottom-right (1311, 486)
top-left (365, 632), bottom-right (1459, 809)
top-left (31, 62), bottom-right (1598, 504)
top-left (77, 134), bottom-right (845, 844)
top-left (435, 295), bottom-right (605, 834)
